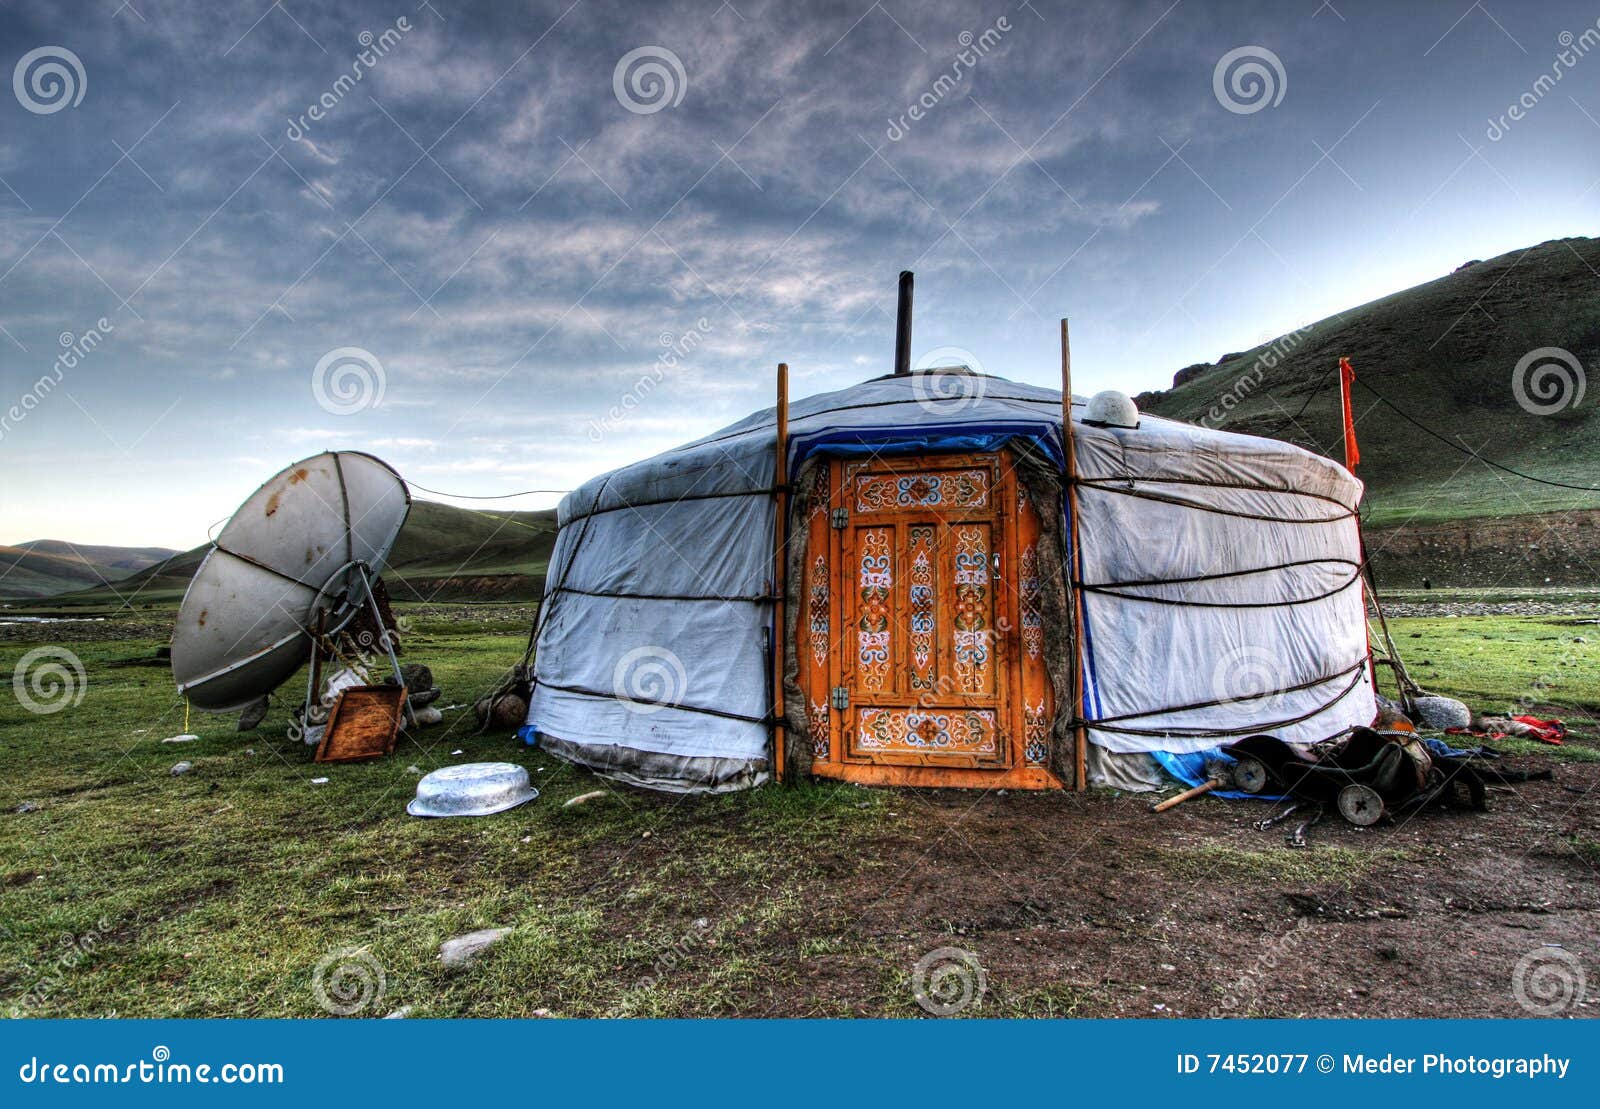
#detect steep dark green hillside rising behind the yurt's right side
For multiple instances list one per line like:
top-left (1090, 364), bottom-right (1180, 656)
top-left (1138, 238), bottom-right (1600, 531)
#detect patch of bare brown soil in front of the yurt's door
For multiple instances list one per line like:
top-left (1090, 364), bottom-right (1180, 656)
top-left (624, 757), bottom-right (1600, 1018)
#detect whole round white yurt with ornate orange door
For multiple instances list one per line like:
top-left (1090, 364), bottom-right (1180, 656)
top-left (522, 302), bottom-right (1374, 792)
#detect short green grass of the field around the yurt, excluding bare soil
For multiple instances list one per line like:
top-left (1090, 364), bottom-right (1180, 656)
top-left (0, 608), bottom-right (1600, 1016)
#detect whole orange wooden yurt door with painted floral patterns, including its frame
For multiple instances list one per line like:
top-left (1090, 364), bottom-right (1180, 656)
top-left (795, 454), bottom-right (1059, 789)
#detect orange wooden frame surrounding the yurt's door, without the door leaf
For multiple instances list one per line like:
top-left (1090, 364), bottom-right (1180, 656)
top-left (797, 450), bottom-right (1062, 789)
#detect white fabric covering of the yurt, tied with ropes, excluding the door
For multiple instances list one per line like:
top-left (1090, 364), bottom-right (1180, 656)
top-left (523, 370), bottom-right (1374, 791)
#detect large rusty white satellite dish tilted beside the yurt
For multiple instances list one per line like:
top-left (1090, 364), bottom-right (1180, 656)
top-left (173, 451), bottom-right (411, 712)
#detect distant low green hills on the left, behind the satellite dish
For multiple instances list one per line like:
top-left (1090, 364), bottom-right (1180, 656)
top-left (0, 501), bottom-right (555, 605)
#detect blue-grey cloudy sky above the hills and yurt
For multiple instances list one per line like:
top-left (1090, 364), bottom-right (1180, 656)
top-left (0, 0), bottom-right (1600, 547)
